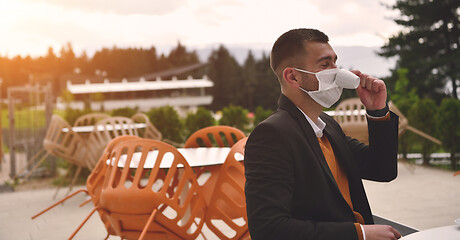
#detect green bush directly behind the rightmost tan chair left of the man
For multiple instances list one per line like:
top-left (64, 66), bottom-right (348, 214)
top-left (147, 106), bottom-right (183, 143)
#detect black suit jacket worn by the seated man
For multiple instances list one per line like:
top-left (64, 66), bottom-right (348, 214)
top-left (244, 95), bottom-right (398, 240)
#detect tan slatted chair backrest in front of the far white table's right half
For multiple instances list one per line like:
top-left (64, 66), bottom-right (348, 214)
top-left (88, 117), bottom-right (138, 167)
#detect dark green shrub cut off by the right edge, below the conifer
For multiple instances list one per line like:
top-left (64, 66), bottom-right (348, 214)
top-left (437, 98), bottom-right (460, 170)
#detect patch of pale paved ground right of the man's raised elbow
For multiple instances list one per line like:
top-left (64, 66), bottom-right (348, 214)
top-left (364, 161), bottom-right (460, 230)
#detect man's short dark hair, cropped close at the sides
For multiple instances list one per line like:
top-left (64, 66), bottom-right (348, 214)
top-left (270, 28), bottom-right (329, 74)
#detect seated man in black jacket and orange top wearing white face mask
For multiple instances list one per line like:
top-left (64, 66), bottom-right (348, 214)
top-left (244, 29), bottom-right (401, 240)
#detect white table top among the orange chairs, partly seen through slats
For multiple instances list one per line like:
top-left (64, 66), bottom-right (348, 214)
top-left (107, 147), bottom-right (244, 169)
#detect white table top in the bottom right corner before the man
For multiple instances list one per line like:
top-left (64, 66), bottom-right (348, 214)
top-left (401, 225), bottom-right (460, 240)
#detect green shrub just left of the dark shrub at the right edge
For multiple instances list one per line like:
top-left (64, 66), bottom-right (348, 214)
top-left (407, 99), bottom-right (438, 165)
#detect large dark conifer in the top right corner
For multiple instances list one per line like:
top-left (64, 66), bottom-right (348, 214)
top-left (379, 0), bottom-right (460, 101)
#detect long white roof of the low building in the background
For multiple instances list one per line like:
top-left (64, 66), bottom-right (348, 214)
top-left (67, 76), bottom-right (214, 94)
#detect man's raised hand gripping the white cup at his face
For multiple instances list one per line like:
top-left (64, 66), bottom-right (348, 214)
top-left (351, 70), bottom-right (387, 110)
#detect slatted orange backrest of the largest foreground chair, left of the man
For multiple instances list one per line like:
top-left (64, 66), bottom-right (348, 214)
top-left (100, 138), bottom-right (206, 239)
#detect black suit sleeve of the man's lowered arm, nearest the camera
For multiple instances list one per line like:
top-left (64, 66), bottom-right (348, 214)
top-left (244, 124), bottom-right (358, 240)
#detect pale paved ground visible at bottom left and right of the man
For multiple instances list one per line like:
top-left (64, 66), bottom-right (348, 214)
top-left (0, 158), bottom-right (460, 240)
